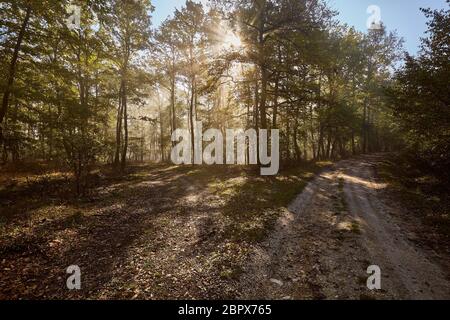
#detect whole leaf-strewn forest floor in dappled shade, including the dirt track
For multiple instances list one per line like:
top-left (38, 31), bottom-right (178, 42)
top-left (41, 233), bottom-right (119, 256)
top-left (0, 155), bottom-right (450, 299)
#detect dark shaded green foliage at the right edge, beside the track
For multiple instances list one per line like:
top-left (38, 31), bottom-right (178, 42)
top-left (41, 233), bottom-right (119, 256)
top-left (388, 3), bottom-right (450, 178)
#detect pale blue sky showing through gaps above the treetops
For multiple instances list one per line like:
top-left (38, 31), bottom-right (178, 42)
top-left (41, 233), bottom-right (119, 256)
top-left (152, 0), bottom-right (448, 54)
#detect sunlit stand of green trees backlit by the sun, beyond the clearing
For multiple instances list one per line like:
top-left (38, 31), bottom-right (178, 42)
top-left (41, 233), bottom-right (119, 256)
top-left (0, 0), bottom-right (442, 192)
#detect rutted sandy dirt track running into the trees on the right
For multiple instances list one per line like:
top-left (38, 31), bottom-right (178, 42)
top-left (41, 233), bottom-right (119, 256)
top-left (242, 155), bottom-right (450, 299)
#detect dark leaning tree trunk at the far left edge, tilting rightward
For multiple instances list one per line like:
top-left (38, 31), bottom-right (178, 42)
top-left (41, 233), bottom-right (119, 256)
top-left (0, 5), bottom-right (31, 146)
